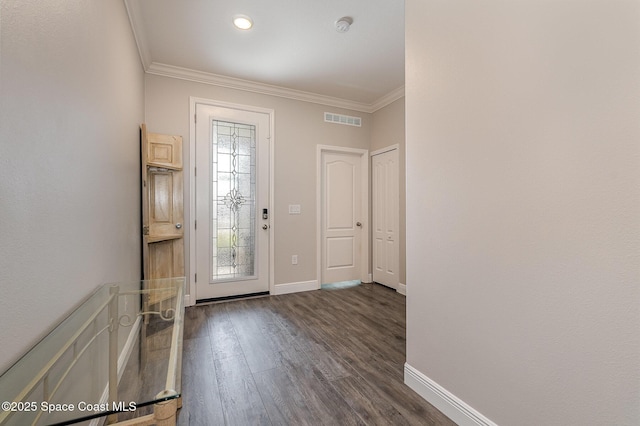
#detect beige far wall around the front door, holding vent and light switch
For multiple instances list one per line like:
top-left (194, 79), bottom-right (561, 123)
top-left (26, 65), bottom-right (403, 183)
top-left (145, 75), bottom-right (371, 292)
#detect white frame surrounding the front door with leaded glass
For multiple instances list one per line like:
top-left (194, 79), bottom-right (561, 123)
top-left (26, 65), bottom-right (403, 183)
top-left (185, 96), bottom-right (275, 306)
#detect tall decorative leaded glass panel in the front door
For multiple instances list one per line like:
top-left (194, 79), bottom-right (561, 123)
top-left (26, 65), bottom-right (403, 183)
top-left (211, 120), bottom-right (256, 281)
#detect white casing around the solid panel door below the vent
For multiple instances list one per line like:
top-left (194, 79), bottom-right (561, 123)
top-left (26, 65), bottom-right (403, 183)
top-left (316, 145), bottom-right (372, 289)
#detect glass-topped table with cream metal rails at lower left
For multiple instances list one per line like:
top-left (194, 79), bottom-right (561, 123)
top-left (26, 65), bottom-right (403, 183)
top-left (0, 278), bottom-right (184, 426)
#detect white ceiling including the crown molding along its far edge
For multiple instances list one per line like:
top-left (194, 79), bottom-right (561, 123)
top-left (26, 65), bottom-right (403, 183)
top-left (125, 0), bottom-right (404, 111)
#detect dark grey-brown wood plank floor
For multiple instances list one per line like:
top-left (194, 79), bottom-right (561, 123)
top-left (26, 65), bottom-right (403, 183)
top-left (178, 284), bottom-right (454, 425)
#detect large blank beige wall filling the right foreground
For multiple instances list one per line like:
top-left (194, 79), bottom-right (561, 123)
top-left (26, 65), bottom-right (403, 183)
top-left (406, 0), bottom-right (640, 426)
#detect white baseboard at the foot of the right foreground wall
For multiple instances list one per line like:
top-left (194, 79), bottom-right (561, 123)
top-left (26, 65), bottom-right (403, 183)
top-left (404, 363), bottom-right (497, 426)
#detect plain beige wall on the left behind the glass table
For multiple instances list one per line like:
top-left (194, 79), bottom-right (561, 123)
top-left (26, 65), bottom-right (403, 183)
top-left (0, 0), bottom-right (144, 372)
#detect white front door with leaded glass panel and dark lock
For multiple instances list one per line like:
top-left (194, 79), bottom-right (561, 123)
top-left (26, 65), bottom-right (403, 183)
top-left (195, 103), bottom-right (271, 300)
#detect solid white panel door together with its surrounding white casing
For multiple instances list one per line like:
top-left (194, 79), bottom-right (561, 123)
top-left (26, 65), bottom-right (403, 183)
top-left (318, 145), bottom-right (369, 284)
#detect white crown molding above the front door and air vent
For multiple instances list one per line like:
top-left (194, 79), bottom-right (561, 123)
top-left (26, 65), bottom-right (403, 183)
top-left (148, 62), bottom-right (404, 113)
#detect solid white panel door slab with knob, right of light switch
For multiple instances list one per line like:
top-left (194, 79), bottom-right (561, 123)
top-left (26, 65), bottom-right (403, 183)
top-left (321, 151), bottom-right (366, 284)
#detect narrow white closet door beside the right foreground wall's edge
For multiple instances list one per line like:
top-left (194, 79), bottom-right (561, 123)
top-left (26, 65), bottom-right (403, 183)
top-left (371, 149), bottom-right (400, 289)
